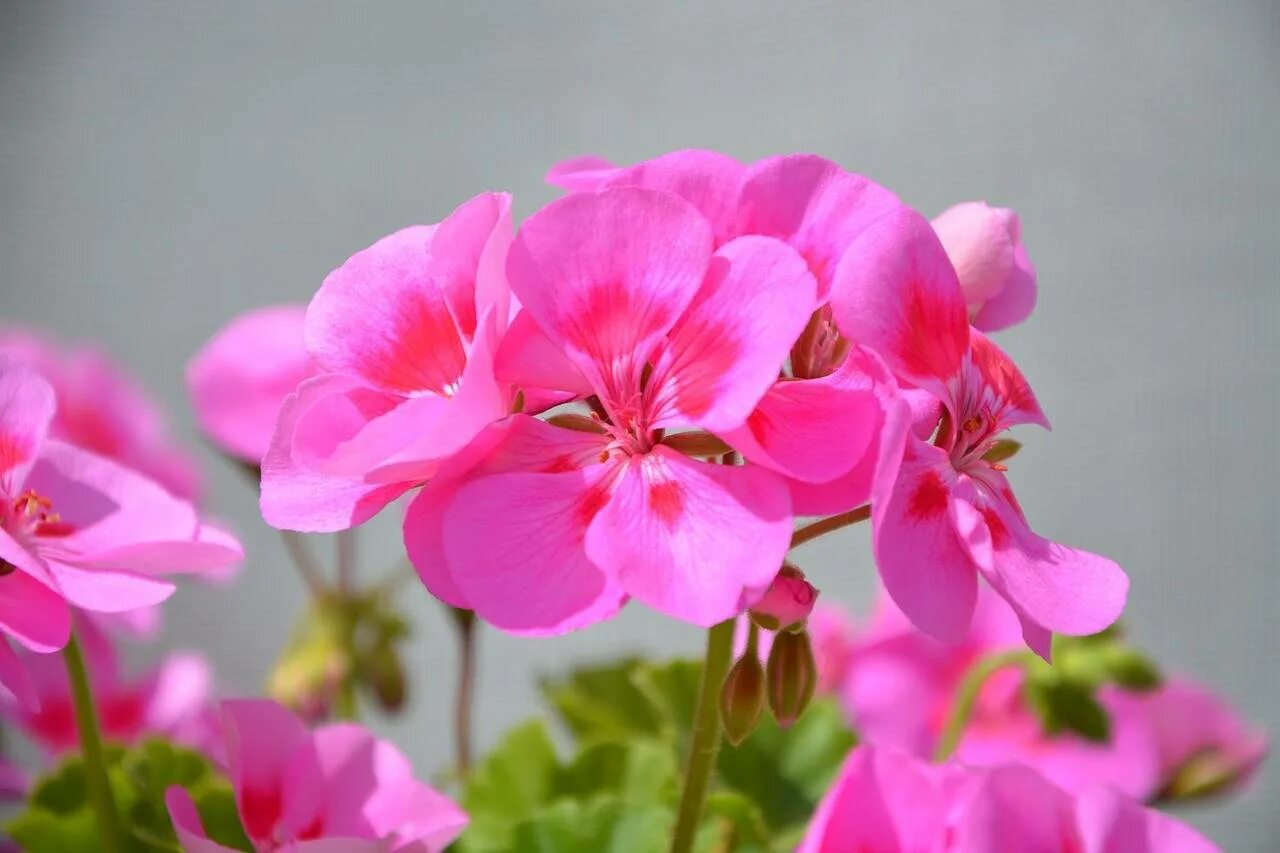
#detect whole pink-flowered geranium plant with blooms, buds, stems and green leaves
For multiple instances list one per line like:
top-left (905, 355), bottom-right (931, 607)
top-left (0, 150), bottom-right (1268, 853)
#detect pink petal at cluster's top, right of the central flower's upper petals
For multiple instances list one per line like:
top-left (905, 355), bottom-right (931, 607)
top-left (735, 154), bottom-right (901, 302)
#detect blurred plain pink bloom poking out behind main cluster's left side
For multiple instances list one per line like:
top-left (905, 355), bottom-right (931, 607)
top-left (187, 305), bottom-right (315, 465)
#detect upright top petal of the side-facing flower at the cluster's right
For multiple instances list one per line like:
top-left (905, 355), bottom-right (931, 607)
top-left (831, 207), bottom-right (969, 397)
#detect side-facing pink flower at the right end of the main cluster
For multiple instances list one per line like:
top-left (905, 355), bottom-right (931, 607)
top-left (832, 207), bottom-right (1129, 658)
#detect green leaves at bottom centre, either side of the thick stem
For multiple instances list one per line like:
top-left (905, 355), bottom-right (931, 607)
top-left (457, 660), bottom-right (854, 853)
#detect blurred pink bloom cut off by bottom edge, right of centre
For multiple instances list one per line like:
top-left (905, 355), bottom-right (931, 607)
top-left (797, 747), bottom-right (1217, 853)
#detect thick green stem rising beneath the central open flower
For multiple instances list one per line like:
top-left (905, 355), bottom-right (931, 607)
top-left (671, 619), bottom-right (733, 853)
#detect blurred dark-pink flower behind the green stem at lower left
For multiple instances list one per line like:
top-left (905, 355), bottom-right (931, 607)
top-left (0, 620), bottom-right (212, 756)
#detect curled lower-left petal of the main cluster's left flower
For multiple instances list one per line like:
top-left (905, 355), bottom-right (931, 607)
top-left (260, 375), bottom-right (411, 532)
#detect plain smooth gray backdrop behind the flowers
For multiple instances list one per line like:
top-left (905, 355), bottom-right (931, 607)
top-left (0, 1), bottom-right (1280, 850)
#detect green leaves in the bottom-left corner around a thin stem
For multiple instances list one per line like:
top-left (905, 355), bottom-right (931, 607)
top-left (5, 739), bottom-right (252, 853)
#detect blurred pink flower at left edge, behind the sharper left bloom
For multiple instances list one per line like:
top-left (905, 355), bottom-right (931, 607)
top-left (0, 328), bottom-right (201, 501)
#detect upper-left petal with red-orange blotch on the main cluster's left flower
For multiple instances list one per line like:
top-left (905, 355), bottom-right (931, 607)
top-left (306, 225), bottom-right (466, 394)
